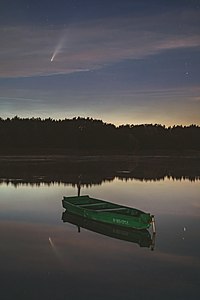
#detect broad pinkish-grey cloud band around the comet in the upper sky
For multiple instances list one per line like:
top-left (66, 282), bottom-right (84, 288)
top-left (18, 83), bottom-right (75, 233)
top-left (0, 12), bottom-right (200, 78)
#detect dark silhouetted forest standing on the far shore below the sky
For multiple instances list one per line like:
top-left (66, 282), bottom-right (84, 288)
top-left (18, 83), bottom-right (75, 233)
top-left (0, 116), bottom-right (200, 154)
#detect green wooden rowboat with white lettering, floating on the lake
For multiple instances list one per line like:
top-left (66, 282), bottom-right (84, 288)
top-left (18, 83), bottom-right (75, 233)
top-left (62, 195), bottom-right (153, 230)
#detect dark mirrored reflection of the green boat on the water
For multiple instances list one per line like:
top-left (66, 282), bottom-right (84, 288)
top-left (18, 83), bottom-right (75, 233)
top-left (62, 211), bottom-right (154, 250)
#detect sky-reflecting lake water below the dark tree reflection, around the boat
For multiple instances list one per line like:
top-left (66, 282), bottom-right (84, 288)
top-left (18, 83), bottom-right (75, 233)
top-left (0, 165), bottom-right (200, 300)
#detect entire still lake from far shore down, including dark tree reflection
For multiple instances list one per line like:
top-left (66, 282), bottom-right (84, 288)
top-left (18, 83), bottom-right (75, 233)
top-left (0, 157), bottom-right (200, 300)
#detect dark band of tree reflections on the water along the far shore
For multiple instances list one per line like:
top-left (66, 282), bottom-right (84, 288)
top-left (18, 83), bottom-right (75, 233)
top-left (0, 156), bottom-right (200, 186)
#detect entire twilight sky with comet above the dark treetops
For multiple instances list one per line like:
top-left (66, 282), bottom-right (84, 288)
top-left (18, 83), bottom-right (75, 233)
top-left (0, 0), bottom-right (200, 126)
